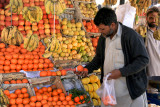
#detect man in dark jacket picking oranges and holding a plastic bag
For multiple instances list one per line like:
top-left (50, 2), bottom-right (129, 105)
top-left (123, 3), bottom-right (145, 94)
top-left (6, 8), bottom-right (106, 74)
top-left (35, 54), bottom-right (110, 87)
top-left (79, 8), bottom-right (149, 107)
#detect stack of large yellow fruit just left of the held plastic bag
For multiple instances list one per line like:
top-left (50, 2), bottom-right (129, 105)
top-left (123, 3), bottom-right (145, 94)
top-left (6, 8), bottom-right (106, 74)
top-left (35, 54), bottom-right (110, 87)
top-left (81, 75), bottom-right (101, 106)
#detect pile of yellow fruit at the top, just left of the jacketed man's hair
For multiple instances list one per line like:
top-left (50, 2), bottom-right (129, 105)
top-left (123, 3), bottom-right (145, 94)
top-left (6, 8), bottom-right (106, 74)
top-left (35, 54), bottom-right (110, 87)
top-left (79, 2), bottom-right (98, 18)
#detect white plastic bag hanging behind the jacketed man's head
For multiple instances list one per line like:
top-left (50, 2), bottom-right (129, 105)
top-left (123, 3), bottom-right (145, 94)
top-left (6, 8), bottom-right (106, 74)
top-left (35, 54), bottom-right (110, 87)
top-left (116, 2), bottom-right (136, 28)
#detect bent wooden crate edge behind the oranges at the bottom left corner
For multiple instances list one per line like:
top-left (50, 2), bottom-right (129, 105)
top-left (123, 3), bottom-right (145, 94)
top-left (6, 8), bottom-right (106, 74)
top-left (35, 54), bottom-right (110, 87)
top-left (2, 83), bottom-right (35, 97)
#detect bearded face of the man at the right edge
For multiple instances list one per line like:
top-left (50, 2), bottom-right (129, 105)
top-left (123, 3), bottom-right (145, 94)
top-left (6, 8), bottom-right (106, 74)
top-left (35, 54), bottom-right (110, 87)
top-left (147, 12), bottom-right (158, 28)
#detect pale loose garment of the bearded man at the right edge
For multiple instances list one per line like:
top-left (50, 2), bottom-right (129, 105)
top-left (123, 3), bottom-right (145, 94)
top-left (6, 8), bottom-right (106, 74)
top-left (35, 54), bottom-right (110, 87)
top-left (146, 29), bottom-right (160, 76)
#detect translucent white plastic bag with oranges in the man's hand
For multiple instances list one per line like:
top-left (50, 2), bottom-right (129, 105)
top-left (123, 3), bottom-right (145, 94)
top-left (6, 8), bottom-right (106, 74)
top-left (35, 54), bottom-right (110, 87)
top-left (96, 73), bottom-right (117, 106)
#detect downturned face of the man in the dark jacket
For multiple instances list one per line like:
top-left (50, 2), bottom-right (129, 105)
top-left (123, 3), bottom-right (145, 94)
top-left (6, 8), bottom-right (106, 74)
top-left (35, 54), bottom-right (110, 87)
top-left (97, 24), bottom-right (114, 38)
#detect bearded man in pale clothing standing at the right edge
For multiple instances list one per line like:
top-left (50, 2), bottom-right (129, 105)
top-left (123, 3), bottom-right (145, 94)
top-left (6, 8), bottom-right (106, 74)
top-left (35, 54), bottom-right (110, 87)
top-left (145, 7), bottom-right (160, 76)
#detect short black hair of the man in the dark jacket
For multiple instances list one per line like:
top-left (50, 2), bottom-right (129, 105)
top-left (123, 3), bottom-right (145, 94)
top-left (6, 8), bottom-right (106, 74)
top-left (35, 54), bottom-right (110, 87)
top-left (94, 7), bottom-right (117, 26)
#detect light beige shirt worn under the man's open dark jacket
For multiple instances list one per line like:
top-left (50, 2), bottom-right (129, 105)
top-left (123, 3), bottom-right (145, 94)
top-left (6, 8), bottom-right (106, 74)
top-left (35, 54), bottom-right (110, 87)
top-left (104, 24), bottom-right (129, 97)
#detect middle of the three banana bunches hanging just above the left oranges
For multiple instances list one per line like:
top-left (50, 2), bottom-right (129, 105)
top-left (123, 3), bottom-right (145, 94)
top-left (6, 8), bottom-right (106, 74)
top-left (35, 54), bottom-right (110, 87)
top-left (24, 33), bottom-right (39, 51)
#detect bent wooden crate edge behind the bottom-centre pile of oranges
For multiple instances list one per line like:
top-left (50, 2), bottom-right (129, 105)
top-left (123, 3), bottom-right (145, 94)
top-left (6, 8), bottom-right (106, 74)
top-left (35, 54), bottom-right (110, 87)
top-left (29, 76), bottom-right (66, 95)
